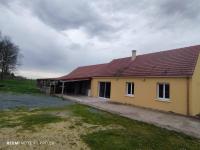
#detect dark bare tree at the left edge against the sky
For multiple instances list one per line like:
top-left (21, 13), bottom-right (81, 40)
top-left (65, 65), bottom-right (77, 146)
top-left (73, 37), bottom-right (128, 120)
top-left (0, 32), bottom-right (19, 80)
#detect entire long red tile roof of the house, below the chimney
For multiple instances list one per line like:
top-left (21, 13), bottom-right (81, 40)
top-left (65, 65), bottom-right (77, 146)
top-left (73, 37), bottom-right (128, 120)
top-left (59, 45), bottom-right (200, 80)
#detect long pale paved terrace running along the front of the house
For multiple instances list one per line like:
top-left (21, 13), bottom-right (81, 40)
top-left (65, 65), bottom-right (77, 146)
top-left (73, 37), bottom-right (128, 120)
top-left (57, 95), bottom-right (200, 138)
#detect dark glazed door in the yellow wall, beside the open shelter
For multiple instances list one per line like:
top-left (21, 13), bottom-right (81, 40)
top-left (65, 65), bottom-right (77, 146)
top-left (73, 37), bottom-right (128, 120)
top-left (99, 82), bottom-right (111, 98)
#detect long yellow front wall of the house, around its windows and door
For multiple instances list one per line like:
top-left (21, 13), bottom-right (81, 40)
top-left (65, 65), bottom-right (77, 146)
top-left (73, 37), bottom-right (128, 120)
top-left (91, 77), bottom-right (189, 115)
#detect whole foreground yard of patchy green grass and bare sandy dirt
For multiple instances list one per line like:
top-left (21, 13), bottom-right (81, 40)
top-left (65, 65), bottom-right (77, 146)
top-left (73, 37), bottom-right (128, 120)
top-left (0, 104), bottom-right (200, 150)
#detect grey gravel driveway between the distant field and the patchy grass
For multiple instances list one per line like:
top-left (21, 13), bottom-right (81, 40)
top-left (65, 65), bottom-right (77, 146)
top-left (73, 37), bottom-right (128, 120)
top-left (0, 93), bottom-right (73, 110)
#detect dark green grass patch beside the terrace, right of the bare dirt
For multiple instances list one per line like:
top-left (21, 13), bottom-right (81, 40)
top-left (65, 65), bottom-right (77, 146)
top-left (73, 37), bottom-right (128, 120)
top-left (71, 105), bottom-right (200, 150)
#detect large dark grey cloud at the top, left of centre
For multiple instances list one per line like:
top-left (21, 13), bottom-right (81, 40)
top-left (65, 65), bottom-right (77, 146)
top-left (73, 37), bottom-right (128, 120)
top-left (25, 0), bottom-right (115, 35)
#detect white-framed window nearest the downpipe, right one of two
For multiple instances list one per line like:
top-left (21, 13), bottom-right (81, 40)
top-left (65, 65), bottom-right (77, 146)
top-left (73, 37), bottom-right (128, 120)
top-left (157, 83), bottom-right (170, 100)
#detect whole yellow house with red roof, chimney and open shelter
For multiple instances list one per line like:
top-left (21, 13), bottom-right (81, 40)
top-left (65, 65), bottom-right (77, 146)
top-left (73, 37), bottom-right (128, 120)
top-left (38, 45), bottom-right (200, 116)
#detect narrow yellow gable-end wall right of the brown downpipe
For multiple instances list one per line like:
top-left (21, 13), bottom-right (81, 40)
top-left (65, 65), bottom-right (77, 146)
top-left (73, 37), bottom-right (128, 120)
top-left (190, 55), bottom-right (200, 115)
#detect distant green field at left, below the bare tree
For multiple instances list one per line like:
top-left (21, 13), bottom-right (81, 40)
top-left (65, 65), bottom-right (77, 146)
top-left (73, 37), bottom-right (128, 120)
top-left (0, 80), bottom-right (41, 94)
